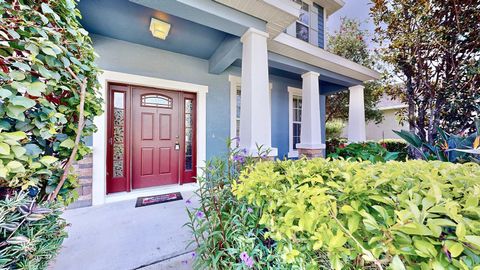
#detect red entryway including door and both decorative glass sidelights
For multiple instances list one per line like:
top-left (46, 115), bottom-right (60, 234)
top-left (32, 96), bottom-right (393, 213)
top-left (106, 83), bottom-right (197, 193)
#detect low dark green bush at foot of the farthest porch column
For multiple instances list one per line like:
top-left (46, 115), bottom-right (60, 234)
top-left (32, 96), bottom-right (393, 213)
top-left (328, 142), bottom-right (398, 162)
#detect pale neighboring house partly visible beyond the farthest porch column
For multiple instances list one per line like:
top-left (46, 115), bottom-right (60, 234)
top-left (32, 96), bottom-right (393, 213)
top-left (367, 95), bottom-right (409, 141)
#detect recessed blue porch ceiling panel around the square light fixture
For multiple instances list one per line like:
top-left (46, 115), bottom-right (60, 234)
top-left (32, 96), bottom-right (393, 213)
top-left (78, 0), bottom-right (230, 59)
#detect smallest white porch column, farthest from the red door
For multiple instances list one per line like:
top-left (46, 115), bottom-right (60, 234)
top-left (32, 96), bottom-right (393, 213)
top-left (348, 85), bottom-right (367, 142)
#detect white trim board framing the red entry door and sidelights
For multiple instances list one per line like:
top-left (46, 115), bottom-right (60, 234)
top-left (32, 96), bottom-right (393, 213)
top-left (92, 70), bottom-right (208, 205)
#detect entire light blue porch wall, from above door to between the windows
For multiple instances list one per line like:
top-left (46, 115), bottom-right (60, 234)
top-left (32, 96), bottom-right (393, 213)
top-left (92, 35), bottom-right (331, 159)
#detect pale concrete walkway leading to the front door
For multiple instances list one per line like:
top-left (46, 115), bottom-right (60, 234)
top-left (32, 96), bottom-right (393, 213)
top-left (50, 192), bottom-right (197, 270)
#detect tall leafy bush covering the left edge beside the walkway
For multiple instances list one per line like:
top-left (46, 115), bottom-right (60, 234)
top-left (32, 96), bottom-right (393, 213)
top-left (0, 0), bottom-right (102, 269)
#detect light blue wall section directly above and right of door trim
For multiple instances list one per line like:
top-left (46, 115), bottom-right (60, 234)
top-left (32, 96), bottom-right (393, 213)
top-left (92, 35), bottom-right (230, 158)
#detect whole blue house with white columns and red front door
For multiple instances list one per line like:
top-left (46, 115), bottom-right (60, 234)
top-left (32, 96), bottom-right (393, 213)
top-left (72, 0), bottom-right (379, 208)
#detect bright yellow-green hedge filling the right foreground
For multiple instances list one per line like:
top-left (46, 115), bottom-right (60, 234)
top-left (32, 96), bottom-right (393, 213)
top-left (233, 159), bottom-right (480, 270)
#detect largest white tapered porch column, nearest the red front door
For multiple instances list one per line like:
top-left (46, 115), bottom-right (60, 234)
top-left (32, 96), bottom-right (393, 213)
top-left (240, 28), bottom-right (277, 156)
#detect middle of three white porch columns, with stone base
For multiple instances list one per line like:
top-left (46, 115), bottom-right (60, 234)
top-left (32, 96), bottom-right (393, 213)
top-left (297, 71), bottom-right (325, 157)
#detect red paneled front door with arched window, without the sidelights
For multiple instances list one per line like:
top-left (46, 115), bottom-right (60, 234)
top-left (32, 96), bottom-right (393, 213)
top-left (132, 87), bottom-right (181, 188)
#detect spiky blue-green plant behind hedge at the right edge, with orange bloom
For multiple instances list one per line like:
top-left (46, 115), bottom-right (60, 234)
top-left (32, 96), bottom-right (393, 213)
top-left (394, 119), bottom-right (480, 163)
